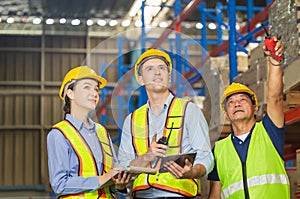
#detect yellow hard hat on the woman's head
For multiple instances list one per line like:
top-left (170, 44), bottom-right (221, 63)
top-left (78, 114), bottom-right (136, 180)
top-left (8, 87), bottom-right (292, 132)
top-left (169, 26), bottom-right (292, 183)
top-left (59, 66), bottom-right (107, 100)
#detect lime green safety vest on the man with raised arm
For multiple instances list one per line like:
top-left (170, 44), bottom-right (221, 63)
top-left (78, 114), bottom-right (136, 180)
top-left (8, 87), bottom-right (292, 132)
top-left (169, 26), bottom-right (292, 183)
top-left (214, 122), bottom-right (290, 199)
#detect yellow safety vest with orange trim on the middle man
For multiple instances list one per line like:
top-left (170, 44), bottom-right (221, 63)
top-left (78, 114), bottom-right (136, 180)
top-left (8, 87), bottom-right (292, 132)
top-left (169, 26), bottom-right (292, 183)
top-left (131, 97), bottom-right (201, 196)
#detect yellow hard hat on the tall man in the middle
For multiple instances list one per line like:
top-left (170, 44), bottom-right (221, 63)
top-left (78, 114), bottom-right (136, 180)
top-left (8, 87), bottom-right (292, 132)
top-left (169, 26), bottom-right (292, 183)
top-left (134, 48), bottom-right (172, 80)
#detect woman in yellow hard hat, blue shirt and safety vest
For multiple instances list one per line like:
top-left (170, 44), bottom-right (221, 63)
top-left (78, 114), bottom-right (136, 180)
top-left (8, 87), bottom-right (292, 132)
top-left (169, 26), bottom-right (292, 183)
top-left (47, 66), bottom-right (131, 199)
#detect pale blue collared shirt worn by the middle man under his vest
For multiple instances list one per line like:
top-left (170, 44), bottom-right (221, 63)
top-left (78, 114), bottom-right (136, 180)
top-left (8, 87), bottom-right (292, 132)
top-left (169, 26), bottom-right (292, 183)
top-left (118, 94), bottom-right (214, 198)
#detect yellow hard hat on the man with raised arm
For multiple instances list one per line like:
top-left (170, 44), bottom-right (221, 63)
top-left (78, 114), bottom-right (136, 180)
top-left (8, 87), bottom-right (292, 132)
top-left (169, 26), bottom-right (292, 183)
top-left (220, 82), bottom-right (258, 112)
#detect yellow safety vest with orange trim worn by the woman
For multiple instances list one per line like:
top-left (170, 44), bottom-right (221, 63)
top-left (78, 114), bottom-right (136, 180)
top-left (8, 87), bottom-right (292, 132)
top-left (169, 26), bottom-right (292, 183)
top-left (52, 120), bottom-right (114, 199)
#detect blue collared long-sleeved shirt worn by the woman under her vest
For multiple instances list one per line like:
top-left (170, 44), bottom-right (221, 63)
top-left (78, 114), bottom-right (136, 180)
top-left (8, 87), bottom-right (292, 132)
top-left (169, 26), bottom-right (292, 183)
top-left (47, 114), bottom-right (117, 195)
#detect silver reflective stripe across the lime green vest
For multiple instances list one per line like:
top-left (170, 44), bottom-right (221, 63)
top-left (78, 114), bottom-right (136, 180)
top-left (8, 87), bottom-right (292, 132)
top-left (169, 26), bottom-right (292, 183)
top-left (222, 174), bottom-right (290, 198)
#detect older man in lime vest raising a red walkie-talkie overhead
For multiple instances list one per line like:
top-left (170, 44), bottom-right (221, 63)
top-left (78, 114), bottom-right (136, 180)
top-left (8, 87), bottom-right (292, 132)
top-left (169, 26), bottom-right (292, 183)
top-left (208, 37), bottom-right (290, 199)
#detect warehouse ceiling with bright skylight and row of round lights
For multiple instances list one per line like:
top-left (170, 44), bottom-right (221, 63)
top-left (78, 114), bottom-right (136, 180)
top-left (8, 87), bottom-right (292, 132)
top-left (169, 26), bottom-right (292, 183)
top-left (0, 0), bottom-right (266, 36)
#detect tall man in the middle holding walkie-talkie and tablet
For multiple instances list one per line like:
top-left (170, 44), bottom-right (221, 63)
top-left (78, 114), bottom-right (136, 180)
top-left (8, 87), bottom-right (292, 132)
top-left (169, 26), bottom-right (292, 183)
top-left (118, 48), bottom-right (213, 199)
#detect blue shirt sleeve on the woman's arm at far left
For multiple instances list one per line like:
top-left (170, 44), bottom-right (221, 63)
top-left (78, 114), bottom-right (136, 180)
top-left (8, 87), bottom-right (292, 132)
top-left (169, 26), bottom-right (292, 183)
top-left (47, 129), bottom-right (99, 195)
